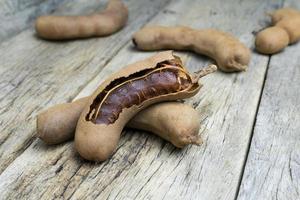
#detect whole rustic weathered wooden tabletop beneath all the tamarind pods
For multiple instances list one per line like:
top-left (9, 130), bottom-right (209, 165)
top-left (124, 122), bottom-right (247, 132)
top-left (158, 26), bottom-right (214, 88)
top-left (0, 0), bottom-right (300, 200)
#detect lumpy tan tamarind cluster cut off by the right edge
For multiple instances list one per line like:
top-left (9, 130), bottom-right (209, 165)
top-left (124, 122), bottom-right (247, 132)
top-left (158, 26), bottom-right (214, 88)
top-left (255, 8), bottom-right (300, 54)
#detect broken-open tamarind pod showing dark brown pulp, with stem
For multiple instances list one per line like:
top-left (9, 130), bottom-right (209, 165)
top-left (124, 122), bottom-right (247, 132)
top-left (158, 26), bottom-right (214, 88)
top-left (75, 51), bottom-right (216, 161)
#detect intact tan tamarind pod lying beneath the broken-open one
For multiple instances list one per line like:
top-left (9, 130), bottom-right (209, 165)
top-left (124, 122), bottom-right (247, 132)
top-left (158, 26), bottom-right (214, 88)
top-left (37, 97), bottom-right (201, 148)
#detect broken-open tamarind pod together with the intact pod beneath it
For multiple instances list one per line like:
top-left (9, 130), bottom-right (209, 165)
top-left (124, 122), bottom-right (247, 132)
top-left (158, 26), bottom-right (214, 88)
top-left (37, 51), bottom-right (217, 161)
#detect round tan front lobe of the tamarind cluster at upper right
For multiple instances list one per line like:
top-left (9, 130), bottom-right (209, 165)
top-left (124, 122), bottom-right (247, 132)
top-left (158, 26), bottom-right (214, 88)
top-left (255, 26), bottom-right (289, 54)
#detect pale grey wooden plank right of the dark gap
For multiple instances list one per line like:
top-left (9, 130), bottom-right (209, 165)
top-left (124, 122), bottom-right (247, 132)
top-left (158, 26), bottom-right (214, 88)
top-left (238, 1), bottom-right (300, 200)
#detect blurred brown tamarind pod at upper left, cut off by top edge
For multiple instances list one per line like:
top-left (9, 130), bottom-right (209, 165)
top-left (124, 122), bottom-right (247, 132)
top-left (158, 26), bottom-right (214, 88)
top-left (35, 0), bottom-right (128, 40)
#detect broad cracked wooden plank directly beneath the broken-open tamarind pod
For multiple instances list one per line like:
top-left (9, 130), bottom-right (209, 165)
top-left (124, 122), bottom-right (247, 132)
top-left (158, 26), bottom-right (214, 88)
top-left (0, 0), bottom-right (280, 199)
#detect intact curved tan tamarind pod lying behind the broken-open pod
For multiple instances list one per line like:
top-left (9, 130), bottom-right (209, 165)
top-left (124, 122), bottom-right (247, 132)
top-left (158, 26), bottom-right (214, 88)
top-left (132, 26), bottom-right (250, 72)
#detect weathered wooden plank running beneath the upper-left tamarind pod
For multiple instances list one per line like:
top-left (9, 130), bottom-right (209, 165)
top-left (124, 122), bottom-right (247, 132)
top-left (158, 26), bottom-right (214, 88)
top-left (0, 0), bottom-right (168, 172)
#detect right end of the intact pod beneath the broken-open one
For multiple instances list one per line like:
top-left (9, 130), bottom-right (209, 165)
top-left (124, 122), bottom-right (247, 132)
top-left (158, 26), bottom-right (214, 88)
top-left (126, 102), bottom-right (202, 148)
